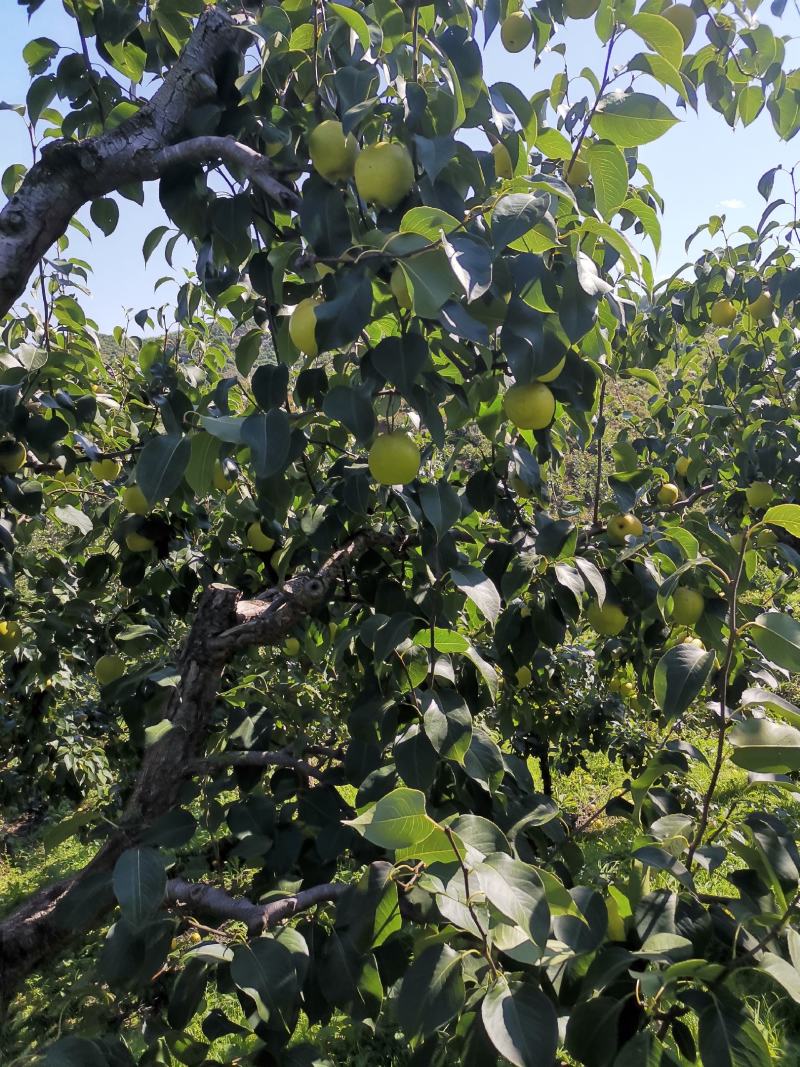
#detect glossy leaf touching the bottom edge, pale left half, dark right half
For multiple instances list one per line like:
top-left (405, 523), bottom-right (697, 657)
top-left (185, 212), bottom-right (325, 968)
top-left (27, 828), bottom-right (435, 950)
top-left (481, 977), bottom-right (558, 1067)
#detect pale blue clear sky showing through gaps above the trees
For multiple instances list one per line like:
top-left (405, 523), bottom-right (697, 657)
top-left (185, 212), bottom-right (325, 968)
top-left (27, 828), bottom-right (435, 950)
top-left (0, 0), bottom-right (800, 330)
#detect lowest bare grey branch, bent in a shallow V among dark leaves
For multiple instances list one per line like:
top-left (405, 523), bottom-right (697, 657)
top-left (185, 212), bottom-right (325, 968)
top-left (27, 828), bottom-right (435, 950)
top-left (165, 878), bottom-right (348, 937)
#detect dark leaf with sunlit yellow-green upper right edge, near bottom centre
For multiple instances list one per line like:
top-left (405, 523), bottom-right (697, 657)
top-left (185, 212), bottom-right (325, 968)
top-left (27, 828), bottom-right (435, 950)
top-left (397, 944), bottom-right (466, 1037)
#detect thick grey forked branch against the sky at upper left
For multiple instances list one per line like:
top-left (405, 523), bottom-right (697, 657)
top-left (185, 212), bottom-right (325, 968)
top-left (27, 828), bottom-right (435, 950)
top-left (0, 7), bottom-right (295, 316)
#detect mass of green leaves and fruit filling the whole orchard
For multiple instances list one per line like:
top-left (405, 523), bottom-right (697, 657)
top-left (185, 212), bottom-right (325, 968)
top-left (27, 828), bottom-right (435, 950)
top-left (0, 0), bottom-right (800, 1067)
